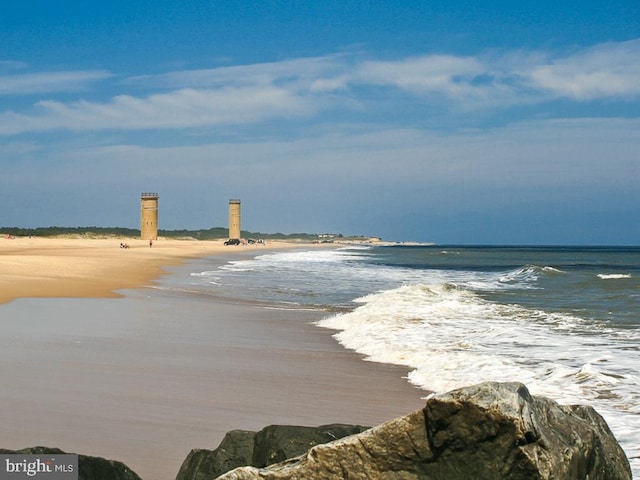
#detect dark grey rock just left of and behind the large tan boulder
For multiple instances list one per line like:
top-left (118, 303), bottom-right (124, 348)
top-left (176, 424), bottom-right (369, 480)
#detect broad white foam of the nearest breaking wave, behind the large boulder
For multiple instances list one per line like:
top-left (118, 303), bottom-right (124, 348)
top-left (318, 284), bottom-right (640, 472)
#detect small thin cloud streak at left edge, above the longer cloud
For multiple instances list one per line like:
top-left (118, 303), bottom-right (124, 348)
top-left (0, 70), bottom-right (112, 95)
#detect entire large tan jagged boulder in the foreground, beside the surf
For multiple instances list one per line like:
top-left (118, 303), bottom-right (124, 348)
top-left (219, 383), bottom-right (631, 480)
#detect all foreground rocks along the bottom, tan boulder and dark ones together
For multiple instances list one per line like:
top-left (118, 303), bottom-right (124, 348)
top-left (0, 383), bottom-right (631, 480)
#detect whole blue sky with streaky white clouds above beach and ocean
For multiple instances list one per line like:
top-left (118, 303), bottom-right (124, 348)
top-left (0, 0), bottom-right (640, 245)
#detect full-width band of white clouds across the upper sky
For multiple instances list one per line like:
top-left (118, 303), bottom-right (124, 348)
top-left (0, 40), bottom-right (640, 135)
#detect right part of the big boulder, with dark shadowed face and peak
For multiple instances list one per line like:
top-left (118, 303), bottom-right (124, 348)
top-left (424, 383), bottom-right (631, 480)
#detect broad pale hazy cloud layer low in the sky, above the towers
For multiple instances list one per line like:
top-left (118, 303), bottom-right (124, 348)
top-left (40, 118), bottom-right (640, 189)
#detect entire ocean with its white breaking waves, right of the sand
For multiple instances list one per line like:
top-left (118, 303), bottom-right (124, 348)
top-left (189, 245), bottom-right (640, 478)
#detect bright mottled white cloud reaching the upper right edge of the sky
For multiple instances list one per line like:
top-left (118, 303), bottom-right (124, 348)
top-left (350, 40), bottom-right (640, 107)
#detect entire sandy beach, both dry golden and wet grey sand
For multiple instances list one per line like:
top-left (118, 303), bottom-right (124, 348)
top-left (0, 239), bottom-right (425, 480)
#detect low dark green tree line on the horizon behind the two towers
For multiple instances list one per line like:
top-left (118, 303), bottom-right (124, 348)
top-left (0, 227), bottom-right (344, 241)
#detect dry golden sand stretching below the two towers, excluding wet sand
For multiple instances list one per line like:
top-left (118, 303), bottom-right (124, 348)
top-left (0, 237), bottom-right (313, 304)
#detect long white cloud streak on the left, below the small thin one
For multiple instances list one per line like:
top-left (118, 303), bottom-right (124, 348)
top-left (0, 86), bottom-right (313, 135)
